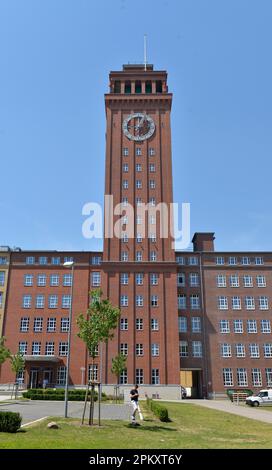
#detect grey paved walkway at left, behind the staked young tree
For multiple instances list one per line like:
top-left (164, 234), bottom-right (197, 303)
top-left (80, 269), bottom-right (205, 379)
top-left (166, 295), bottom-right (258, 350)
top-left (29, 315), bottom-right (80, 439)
top-left (0, 400), bottom-right (130, 424)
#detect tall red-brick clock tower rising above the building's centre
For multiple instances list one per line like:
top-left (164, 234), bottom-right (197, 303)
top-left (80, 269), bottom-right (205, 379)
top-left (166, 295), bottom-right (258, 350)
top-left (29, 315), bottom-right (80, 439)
top-left (103, 65), bottom-right (180, 385)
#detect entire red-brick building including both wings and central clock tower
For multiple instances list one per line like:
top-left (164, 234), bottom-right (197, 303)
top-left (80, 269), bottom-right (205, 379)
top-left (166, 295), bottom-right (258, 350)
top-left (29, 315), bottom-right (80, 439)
top-left (0, 65), bottom-right (272, 398)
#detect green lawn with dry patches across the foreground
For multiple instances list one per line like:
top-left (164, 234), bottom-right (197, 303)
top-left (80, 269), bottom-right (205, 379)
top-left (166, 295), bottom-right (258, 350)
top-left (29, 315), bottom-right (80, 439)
top-left (0, 403), bottom-right (272, 449)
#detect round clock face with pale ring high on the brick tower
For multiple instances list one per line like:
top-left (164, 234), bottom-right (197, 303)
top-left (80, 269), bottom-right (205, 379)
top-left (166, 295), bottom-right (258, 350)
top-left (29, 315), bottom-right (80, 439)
top-left (122, 113), bottom-right (155, 142)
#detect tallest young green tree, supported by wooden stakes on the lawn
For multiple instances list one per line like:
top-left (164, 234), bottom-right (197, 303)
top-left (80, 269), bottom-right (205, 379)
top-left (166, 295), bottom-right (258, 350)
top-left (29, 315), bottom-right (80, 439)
top-left (77, 289), bottom-right (120, 424)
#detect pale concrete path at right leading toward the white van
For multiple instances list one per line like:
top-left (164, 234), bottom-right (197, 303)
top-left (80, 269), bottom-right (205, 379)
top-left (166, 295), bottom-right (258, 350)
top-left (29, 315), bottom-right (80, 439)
top-left (170, 399), bottom-right (272, 424)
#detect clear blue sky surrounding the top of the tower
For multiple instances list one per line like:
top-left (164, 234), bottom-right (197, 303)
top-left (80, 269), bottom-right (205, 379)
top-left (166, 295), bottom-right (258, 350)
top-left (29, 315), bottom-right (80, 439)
top-left (0, 0), bottom-right (272, 250)
